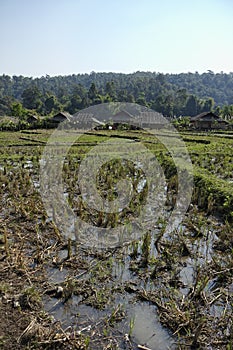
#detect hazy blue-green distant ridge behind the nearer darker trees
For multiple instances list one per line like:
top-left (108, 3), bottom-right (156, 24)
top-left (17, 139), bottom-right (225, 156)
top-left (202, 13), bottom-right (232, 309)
top-left (0, 71), bottom-right (233, 106)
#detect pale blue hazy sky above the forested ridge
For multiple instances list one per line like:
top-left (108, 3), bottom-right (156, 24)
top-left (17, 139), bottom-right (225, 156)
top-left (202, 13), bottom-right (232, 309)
top-left (0, 0), bottom-right (233, 76)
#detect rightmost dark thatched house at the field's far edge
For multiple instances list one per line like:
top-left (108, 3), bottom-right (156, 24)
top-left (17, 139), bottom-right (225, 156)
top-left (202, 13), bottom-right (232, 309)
top-left (190, 112), bottom-right (229, 130)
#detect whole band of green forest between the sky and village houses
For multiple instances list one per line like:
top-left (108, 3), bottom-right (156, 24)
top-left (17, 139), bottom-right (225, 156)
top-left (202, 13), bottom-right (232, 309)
top-left (0, 71), bottom-right (233, 119)
